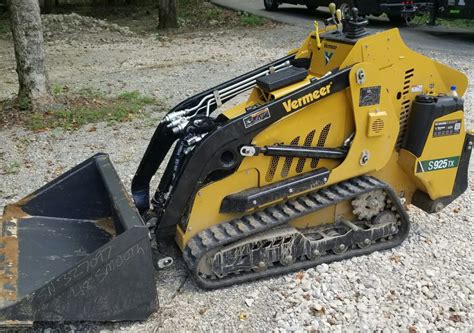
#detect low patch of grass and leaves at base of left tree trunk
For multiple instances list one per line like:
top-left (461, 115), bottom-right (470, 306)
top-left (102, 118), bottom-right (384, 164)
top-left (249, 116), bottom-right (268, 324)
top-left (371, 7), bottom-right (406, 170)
top-left (26, 90), bottom-right (156, 131)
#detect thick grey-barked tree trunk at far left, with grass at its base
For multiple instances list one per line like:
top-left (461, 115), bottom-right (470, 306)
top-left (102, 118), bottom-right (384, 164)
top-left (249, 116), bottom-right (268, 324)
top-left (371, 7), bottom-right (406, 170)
top-left (8, 0), bottom-right (51, 109)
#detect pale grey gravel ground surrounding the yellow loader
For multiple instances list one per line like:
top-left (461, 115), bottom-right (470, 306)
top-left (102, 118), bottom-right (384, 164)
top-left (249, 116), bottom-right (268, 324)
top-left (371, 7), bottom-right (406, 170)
top-left (0, 12), bottom-right (474, 332)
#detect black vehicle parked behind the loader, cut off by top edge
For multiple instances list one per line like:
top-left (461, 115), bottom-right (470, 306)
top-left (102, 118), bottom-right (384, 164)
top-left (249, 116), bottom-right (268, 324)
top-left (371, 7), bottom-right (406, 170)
top-left (263, 0), bottom-right (434, 23)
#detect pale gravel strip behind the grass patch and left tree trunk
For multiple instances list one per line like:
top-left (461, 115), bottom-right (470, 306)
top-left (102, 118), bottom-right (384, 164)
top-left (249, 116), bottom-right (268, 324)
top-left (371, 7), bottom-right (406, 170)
top-left (0, 9), bottom-right (294, 105)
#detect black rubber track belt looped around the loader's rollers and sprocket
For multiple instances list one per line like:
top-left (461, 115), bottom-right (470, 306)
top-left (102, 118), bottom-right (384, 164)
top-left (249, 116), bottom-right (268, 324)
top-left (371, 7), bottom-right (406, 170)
top-left (183, 176), bottom-right (410, 289)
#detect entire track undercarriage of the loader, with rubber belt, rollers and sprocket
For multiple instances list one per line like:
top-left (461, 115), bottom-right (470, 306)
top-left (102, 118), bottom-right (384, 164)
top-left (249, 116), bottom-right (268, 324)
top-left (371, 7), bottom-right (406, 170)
top-left (184, 176), bottom-right (409, 288)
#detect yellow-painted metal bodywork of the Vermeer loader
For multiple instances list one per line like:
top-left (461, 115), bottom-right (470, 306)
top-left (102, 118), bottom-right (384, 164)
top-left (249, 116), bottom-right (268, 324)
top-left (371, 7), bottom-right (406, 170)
top-left (176, 29), bottom-right (467, 249)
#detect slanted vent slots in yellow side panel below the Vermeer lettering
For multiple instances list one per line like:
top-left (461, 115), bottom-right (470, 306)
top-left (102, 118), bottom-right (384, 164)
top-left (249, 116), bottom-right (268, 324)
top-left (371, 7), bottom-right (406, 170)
top-left (265, 124), bottom-right (331, 182)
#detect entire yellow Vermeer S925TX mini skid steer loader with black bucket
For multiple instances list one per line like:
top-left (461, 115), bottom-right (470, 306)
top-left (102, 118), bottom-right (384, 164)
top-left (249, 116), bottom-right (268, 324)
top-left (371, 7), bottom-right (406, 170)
top-left (0, 6), bottom-right (473, 325)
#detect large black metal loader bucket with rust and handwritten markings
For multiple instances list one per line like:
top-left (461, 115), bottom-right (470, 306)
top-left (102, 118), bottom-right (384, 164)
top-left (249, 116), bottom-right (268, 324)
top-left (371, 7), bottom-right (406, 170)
top-left (0, 154), bottom-right (157, 326)
